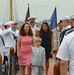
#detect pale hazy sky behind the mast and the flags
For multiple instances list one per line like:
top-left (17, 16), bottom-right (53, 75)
top-left (0, 0), bottom-right (74, 22)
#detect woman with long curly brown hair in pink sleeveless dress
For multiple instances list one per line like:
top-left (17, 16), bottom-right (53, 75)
top-left (17, 23), bottom-right (33, 75)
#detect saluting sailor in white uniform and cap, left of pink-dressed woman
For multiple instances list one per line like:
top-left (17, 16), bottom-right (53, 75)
top-left (3, 22), bottom-right (15, 70)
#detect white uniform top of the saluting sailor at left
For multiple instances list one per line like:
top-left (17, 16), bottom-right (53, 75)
top-left (3, 28), bottom-right (15, 47)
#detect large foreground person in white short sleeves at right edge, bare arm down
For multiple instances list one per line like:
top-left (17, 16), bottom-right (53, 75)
top-left (57, 31), bottom-right (74, 75)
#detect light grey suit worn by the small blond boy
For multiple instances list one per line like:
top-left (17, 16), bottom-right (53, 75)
top-left (32, 46), bottom-right (45, 75)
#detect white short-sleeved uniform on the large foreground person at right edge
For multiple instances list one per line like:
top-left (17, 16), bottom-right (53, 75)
top-left (56, 32), bottom-right (74, 75)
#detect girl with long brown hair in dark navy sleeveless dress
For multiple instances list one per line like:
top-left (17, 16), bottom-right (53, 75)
top-left (39, 22), bottom-right (54, 75)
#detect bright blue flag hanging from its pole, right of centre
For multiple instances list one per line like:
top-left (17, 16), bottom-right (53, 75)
top-left (50, 7), bottom-right (57, 29)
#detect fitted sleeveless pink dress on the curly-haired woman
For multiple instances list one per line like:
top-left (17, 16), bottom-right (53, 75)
top-left (18, 36), bottom-right (33, 66)
